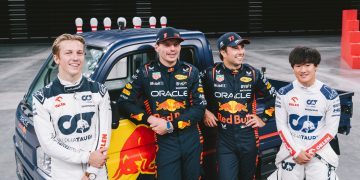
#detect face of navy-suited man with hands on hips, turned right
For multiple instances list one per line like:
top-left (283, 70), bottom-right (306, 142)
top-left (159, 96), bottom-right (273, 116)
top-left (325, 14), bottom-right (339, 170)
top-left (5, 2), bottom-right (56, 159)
top-left (220, 44), bottom-right (245, 69)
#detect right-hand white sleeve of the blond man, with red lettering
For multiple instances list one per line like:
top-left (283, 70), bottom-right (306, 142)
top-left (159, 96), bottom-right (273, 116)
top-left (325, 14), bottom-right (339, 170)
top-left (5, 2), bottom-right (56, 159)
top-left (86, 92), bottom-right (112, 174)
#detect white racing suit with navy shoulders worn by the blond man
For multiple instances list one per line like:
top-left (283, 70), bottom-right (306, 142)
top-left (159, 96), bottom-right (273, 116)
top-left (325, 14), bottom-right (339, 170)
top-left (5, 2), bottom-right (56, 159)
top-left (33, 77), bottom-right (111, 180)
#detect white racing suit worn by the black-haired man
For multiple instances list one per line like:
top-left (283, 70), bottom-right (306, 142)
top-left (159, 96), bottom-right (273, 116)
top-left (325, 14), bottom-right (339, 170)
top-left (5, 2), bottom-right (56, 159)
top-left (268, 80), bottom-right (341, 180)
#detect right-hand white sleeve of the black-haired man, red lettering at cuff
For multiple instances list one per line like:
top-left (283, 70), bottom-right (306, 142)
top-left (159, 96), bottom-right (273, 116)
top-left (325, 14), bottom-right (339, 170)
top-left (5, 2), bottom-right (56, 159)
top-left (306, 96), bottom-right (341, 153)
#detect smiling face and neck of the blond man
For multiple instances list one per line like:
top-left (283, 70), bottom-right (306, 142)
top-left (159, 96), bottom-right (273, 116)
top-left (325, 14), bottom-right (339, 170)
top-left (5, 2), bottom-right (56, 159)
top-left (54, 40), bottom-right (85, 82)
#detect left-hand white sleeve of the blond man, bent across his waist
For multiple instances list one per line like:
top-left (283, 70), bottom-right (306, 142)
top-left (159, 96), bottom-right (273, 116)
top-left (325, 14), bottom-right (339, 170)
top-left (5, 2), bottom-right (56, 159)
top-left (33, 96), bottom-right (90, 164)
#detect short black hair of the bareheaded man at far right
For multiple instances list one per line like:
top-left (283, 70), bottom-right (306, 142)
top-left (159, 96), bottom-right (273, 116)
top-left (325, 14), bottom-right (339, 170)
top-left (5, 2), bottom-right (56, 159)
top-left (289, 46), bottom-right (321, 68)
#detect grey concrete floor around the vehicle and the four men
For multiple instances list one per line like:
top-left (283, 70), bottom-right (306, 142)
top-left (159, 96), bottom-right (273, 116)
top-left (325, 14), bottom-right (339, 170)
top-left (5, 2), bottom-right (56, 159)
top-left (0, 36), bottom-right (360, 180)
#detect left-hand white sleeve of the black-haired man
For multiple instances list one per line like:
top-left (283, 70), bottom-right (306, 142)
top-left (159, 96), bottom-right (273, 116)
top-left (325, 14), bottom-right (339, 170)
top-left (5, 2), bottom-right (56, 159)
top-left (275, 93), bottom-right (301, 158)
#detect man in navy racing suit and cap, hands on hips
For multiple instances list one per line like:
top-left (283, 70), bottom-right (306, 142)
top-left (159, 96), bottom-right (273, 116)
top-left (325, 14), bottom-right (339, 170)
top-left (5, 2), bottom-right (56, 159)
top-left (202, 32), bottom-right (275, 180)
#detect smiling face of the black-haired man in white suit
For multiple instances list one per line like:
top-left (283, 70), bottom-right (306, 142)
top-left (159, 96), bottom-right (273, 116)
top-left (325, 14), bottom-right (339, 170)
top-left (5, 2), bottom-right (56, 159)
top-left (293, 63), bottom-right (317, 87)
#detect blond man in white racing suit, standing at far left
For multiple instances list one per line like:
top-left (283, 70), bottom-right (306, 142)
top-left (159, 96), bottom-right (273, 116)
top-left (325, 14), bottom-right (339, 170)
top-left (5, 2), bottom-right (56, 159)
top-left (33, 34), bottom-right (111, 180)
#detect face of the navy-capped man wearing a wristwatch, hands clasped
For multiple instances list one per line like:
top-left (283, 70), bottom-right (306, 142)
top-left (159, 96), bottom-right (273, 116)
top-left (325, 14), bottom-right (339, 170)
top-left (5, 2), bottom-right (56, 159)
top-left (155, 39), bottom-right (181, 67)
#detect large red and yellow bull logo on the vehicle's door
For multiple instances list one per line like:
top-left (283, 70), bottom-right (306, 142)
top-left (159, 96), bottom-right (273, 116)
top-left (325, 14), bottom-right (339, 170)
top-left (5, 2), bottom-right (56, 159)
top-left (112, 125), bottom-right (156, 179)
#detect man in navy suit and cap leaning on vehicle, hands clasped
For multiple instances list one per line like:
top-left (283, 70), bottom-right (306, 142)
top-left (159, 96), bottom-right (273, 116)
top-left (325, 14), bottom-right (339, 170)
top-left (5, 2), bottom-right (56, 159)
top-left (118, 27), bottom-right (206, 180)
